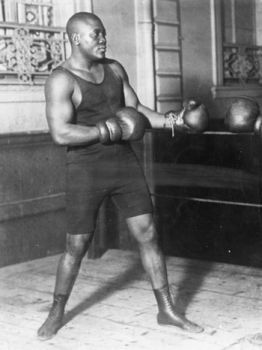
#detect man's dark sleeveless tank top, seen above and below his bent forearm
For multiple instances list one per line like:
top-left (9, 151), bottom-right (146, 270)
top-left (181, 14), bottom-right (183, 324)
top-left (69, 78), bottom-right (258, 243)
top-left (56, 63), bottom-right (131, 163)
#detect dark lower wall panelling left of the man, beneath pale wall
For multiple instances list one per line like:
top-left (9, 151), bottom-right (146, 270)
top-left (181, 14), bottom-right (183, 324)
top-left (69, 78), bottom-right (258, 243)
top-left (0, 132), bottom-right (65, 266)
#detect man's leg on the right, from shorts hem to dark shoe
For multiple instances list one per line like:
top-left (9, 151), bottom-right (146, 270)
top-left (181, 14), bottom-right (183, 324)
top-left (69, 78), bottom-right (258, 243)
top-left (126, 214), bottom-right (203, 333)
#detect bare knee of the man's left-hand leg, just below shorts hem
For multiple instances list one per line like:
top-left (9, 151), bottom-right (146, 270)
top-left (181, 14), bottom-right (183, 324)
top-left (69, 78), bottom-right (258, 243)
top-left (66, 235), bottom-right (90, 260)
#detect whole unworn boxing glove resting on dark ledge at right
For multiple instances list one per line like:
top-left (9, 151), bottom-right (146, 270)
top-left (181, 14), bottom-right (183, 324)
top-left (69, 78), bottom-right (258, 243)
top-left (224, 97), bottom-right (259, 133)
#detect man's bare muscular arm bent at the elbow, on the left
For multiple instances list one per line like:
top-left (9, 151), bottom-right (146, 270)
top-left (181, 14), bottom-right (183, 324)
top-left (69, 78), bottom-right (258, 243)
top-left (45, 72), bottom-right (99, 145)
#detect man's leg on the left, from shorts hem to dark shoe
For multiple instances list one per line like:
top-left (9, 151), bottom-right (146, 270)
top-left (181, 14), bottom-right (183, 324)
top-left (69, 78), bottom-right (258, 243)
top-left (37, 234), bottom-right (93, 340)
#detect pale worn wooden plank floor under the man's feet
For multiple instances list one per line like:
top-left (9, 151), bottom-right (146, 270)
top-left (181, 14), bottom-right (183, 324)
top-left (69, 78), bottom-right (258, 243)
top-left (0, 250), bottom-right (262, 350)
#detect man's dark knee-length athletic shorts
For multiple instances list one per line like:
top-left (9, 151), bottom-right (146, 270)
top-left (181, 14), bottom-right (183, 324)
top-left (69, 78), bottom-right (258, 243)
top-left (66, 142), bottom-right (153, 235)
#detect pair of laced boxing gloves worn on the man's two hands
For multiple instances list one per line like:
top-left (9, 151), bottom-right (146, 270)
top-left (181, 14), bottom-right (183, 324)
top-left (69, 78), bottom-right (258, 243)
top-left (96, 100), bottom-right (208, 144)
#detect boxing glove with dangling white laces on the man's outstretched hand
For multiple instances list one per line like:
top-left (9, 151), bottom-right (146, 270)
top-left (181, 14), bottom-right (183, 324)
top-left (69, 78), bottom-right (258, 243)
top-left (164, 100), bottom-right (209, 136)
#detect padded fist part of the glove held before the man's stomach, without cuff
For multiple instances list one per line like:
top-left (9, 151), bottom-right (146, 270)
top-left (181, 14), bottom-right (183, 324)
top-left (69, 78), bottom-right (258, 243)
top-left (116, 107), bottom-right (147, 141)
